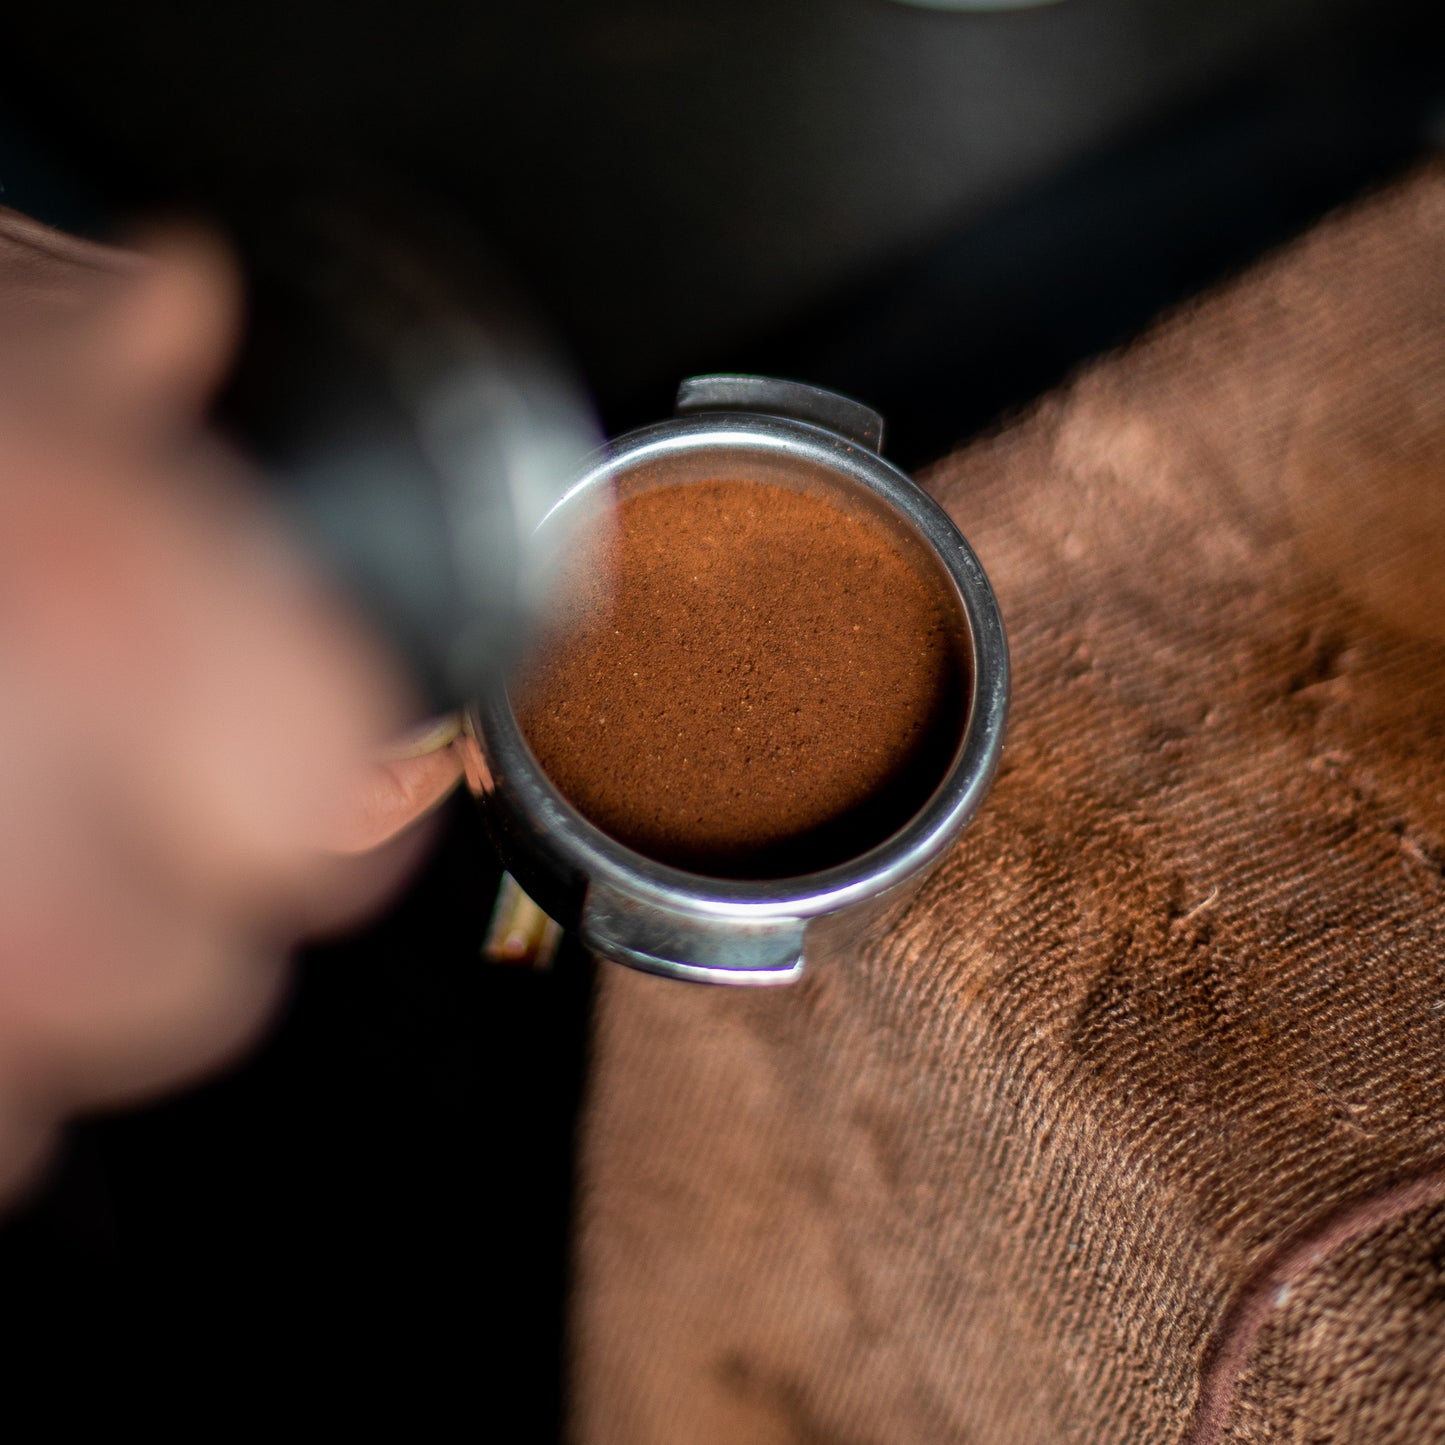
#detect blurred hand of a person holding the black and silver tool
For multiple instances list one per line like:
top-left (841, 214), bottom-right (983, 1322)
top-left (0, 211), bottom-right (460, 1198)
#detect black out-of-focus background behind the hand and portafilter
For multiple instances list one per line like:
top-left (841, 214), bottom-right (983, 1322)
top-left (0, 0), bottom-right (1445, 1441)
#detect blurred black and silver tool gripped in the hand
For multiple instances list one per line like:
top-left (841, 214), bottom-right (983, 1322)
top-left (217, 197), bottom-right (597, 711)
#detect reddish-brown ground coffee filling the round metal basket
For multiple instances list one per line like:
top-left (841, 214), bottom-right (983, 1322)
top-left (514, 481), bottom-right (967, 877)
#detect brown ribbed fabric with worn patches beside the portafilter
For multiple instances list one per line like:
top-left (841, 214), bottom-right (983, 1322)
top-left (574, 169), bottom-right (1445, 1445)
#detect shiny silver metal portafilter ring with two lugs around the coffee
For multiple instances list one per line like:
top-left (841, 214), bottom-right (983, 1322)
top-left (467, 376), bottom-right (1009, 984)
